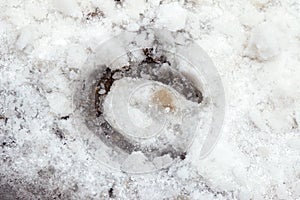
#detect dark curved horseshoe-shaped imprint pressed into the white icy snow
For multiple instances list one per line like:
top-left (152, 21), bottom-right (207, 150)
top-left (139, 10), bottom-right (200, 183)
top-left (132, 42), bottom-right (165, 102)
top-left (95, 48), bottom-right (203, 159)
